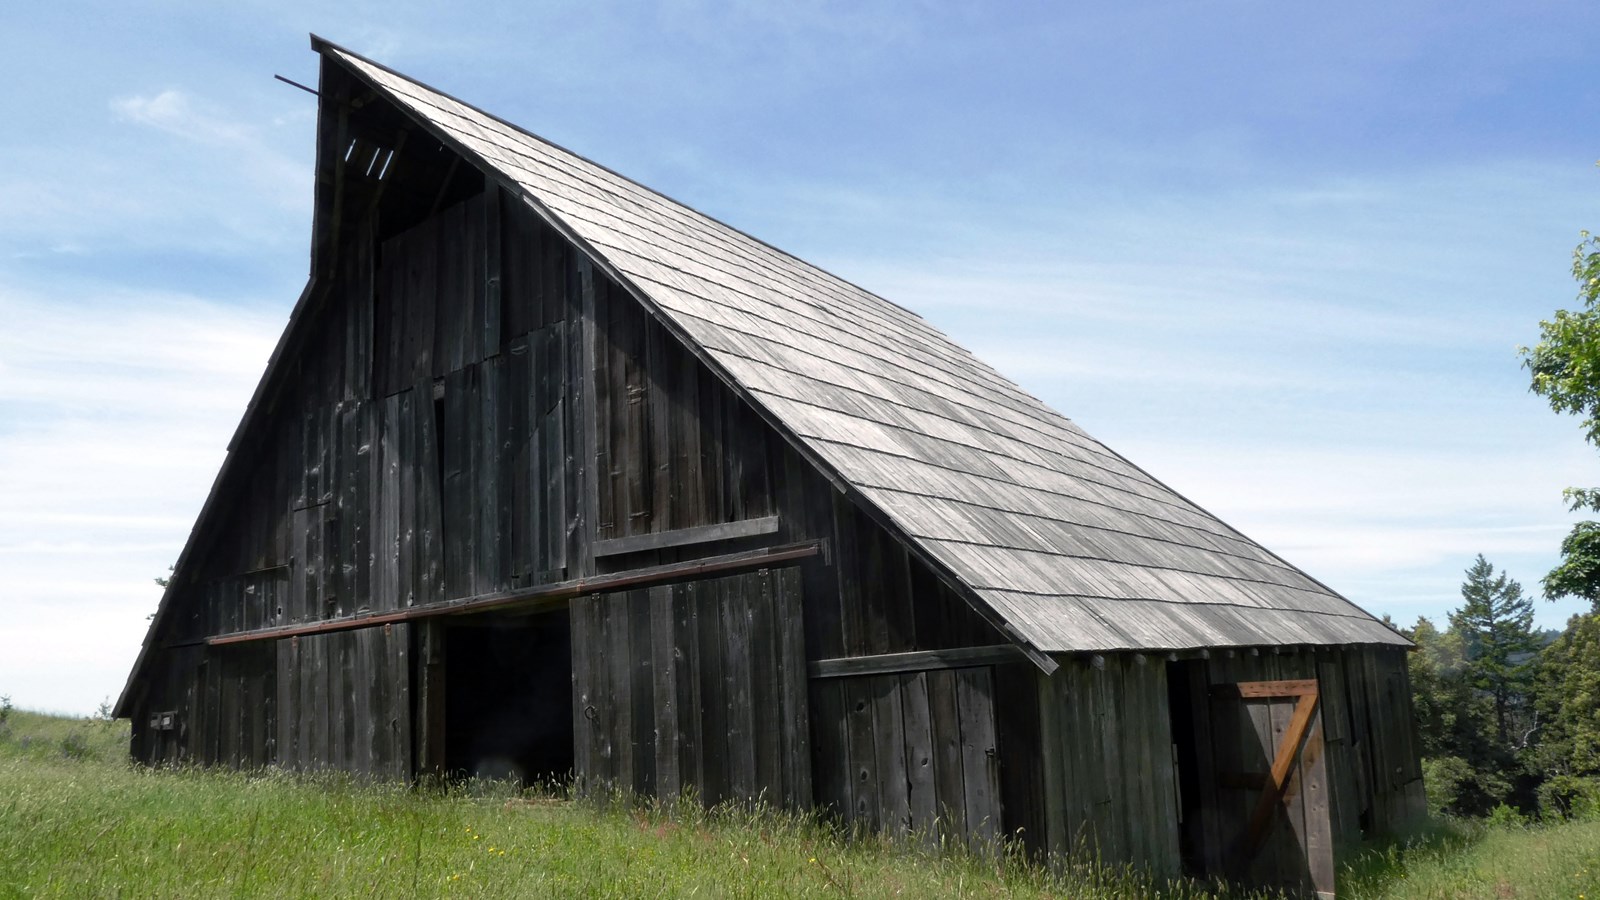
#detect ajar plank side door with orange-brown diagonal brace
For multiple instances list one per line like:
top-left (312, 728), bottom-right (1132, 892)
top-left (1200, 679), bottom-right (1334, 897)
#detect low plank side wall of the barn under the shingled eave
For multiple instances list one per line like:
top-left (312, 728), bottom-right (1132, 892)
top-left (1038, 647), bottom-right (1426, 884)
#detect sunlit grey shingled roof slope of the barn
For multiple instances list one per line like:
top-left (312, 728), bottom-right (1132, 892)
top-left (317, 43), bottom-right (1406, 652)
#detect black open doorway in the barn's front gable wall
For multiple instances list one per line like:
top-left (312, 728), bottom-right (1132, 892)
top-left (445, 610), bottom-right (573, 785)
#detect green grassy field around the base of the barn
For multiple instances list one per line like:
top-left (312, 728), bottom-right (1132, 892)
top-left (0, 711), bottom-right (1600, 900)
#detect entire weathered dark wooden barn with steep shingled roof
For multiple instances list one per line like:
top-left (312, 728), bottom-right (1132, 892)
top-left (117, 38), bottom-right (1421, 892)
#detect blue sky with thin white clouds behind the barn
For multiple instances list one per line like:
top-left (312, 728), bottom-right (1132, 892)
top-left (0, 0), bottom-right (1600, 713)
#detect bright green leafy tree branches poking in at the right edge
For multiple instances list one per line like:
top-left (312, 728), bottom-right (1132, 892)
top-left (1518, 231), bottom-right (1600, 602)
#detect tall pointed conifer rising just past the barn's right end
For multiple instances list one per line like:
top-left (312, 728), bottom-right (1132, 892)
top-left (1450, 554), bottom-right (1539, 749)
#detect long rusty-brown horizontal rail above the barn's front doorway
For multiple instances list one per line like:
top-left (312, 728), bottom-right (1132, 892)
top-left (205, 541), bottom-right (821, 647)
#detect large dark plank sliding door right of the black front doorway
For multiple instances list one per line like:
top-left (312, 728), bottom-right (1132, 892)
top-left (571, 569), bottom-right (811, 807)
